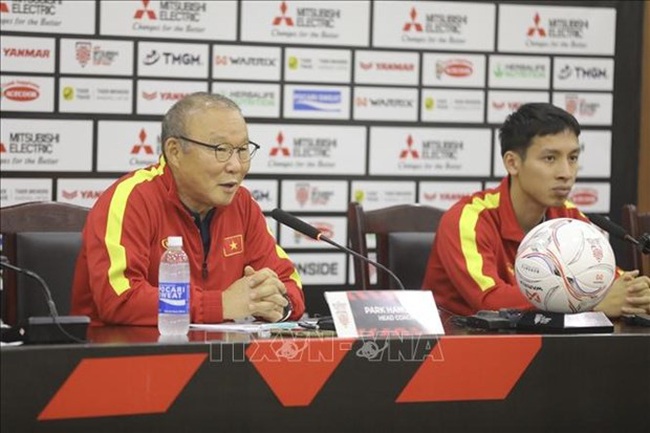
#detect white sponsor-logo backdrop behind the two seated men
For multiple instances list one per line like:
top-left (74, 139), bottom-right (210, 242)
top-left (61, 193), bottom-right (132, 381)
top-left (0, 0), bottom-right (642, 300)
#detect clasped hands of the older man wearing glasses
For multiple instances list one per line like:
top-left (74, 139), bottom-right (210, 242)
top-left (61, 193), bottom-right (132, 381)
top-left (222, 266), bottom-right (288, 322)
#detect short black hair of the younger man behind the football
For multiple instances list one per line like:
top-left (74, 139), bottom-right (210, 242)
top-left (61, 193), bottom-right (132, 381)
top-left (499, 102), bottom-right (580, 158)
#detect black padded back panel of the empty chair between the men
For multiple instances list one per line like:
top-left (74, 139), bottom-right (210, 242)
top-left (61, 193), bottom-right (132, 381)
top-left (388, 232), bottom-right (435, 290)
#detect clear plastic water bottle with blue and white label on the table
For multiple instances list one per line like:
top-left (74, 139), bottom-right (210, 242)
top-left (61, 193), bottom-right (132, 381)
top-left (158, 236), bottom-right (190, 335)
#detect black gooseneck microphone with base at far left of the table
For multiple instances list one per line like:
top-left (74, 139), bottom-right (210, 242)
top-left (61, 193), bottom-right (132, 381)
top-left (0, 255), bottom-right (89, 343)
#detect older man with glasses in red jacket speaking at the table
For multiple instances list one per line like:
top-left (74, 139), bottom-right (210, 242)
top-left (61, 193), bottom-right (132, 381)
top-left (72, 93), bottom-right (305, 326)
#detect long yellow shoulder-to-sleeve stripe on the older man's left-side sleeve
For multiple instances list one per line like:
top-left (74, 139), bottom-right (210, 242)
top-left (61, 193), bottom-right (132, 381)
top-left (104, 158), bottom-right (165, 295)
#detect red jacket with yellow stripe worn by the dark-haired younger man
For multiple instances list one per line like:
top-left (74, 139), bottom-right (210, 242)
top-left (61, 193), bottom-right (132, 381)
top-left (422, 177), bottom-right (588, 316)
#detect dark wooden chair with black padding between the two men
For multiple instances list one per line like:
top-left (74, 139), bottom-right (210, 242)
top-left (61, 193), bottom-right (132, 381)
top-left (348, 202), bottom-right (445, 290)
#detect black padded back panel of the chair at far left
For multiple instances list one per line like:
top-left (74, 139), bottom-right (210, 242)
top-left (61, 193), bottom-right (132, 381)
top-left (15, 232), bottom-right (81, 323)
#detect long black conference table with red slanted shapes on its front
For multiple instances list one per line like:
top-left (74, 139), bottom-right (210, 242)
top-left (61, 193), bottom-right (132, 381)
top-left (0, 312), bottom-right (650, 433)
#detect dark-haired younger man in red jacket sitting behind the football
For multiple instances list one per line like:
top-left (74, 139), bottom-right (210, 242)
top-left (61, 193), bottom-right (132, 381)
top-left (423, 103), bottom-right (650, 317)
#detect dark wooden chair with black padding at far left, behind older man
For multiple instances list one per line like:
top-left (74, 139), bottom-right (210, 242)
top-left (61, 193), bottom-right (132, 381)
top-left (0, 202), bottom-right (89, 325)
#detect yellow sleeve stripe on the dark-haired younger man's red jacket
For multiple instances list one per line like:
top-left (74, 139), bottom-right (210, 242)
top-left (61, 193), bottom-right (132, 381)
top-left (459, 193), bottom-right (499, 291)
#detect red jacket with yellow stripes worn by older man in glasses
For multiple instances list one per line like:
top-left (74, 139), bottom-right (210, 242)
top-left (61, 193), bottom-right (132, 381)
top-left (71, 158), bottom-right (305, 326)
